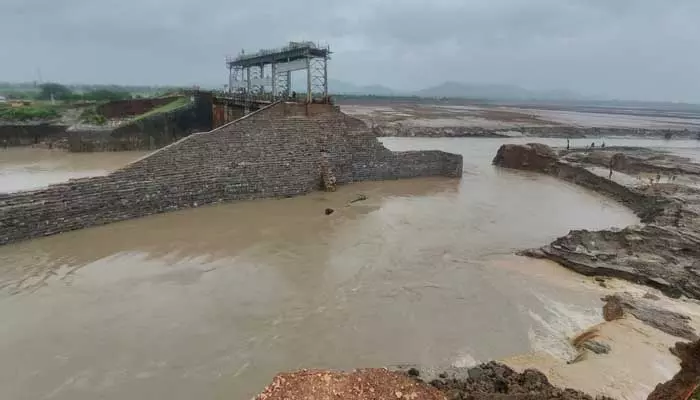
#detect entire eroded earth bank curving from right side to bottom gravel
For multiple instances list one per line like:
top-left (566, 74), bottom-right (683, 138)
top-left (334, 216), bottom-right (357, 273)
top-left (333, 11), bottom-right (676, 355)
top-left (257, 144), bottom-right (700, 400)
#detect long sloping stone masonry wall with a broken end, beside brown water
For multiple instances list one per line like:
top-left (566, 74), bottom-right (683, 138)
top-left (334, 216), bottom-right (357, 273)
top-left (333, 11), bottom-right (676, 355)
top-left (0, 103), bottom-right (462, 244)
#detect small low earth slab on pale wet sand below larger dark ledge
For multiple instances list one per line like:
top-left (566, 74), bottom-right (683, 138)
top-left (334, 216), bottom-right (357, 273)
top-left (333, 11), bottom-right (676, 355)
top-left (603, 293), bottom-right (698, 340)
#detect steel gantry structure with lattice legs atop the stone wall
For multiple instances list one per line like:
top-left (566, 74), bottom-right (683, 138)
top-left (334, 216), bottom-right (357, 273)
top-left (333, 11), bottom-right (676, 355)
top-left (226, 42), bottom-right (331, 102)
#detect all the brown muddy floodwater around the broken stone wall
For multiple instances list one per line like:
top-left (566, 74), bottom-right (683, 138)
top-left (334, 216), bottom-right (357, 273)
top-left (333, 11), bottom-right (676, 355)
top-left (0, 138), bottom-right (700, 400)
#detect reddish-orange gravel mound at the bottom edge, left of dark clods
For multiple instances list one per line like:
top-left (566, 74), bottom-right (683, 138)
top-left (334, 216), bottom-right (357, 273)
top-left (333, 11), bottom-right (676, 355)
top-left (255, 369), bottom-right (445, 400)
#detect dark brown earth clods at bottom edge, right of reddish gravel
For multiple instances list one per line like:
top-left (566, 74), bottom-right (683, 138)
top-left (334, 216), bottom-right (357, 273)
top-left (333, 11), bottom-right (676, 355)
top-left (430, 362), bottom-right (610, 400)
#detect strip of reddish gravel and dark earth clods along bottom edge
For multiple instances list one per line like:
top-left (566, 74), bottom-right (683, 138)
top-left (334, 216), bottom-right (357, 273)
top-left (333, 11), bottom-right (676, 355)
top-left (255, 362), bottom-right (612, 400)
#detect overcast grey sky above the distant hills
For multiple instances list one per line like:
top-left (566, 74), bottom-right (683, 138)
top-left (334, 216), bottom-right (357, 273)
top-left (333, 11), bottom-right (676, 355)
top-left (0, 0), bottom-right (700, 102)
